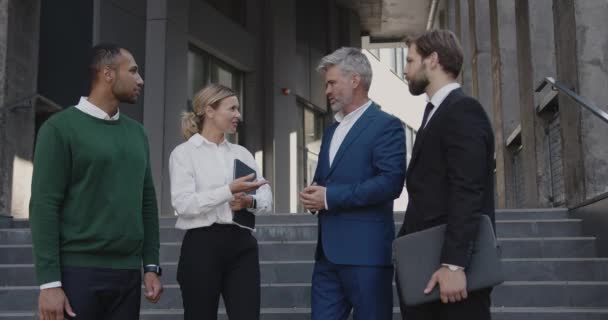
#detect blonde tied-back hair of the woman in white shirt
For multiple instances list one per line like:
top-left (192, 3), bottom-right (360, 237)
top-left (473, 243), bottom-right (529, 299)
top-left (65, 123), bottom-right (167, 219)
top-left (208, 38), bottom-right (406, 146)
top-left (182, 83), bottom-right (236, 140)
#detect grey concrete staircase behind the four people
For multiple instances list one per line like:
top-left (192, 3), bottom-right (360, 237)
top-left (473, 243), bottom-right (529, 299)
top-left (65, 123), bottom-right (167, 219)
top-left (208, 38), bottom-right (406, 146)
top-left (0, 209), bottom-right (608, 320)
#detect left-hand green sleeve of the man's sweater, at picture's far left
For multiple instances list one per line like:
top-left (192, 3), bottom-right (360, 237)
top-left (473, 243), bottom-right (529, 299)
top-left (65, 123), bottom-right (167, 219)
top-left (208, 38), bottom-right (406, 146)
top-left (30, 123), bottom-right (71, 284)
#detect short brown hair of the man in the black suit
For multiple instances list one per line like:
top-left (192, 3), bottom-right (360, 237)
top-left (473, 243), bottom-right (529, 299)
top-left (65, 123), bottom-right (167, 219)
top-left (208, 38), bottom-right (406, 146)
top-left (405, 30), bottom-right (463, 78)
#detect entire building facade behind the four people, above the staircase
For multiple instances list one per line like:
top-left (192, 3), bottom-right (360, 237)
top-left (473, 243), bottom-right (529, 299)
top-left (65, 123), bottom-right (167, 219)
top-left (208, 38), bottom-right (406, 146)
top-left (0, 0), bottom-right (608, 217)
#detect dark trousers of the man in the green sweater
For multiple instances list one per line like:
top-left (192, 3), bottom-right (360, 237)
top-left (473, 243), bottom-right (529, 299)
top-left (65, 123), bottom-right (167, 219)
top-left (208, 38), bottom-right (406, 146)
top-left (61, 267), bottom-right (141, 320)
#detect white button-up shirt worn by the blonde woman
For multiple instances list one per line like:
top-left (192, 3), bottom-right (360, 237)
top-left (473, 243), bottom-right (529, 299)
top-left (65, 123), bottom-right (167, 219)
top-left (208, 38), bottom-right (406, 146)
top-left (169, 133), bottom-right (272, 230)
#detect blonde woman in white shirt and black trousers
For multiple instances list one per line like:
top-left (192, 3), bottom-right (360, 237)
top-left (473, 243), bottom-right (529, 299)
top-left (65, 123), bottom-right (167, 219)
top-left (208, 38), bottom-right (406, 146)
top-left (169, 84), bottom-right (272, 320)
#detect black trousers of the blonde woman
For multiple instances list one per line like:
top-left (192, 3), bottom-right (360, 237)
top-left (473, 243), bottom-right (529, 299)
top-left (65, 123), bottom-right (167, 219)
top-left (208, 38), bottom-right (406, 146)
top-left (177, 224), bottom-right (260, 320)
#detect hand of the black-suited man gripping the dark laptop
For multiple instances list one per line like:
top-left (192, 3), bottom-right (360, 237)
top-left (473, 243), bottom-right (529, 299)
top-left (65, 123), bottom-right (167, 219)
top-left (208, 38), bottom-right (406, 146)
top-left (424, 267), bottom-right (467, 303)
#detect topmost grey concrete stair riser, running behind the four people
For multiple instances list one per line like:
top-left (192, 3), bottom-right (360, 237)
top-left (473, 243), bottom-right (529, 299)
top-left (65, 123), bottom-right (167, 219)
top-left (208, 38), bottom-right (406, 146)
top-left (0, 219), bottom-right (582, 244)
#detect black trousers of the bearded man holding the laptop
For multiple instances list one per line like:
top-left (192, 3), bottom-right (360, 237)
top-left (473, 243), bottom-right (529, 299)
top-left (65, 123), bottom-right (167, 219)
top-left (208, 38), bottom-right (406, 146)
top-left (397, 278), bottom-right (492, 320)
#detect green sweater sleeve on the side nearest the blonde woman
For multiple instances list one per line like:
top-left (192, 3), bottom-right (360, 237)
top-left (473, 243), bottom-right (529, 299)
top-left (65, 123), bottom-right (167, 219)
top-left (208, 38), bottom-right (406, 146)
top-left (142, 137), bottom-right (160, 265)
